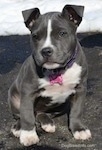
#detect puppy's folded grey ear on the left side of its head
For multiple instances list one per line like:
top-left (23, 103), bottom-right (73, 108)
top-left (22, 8), bottom-right (40, 30)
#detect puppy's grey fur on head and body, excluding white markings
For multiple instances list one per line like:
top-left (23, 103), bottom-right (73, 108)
top-left (8, 5), bottom-right (91, 145)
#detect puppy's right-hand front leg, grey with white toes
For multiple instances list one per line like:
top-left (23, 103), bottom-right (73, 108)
top-left (69, 84), bottom-right (91, 140)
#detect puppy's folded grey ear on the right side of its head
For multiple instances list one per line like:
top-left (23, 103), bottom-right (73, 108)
top-left (62, 5), bottom-right (84, 26)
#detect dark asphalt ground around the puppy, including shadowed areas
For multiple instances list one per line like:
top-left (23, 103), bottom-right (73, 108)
top-left (0, 33), bottom-right (102, 150)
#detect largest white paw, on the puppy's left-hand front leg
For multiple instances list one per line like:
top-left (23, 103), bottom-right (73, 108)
top-left (20, 130), bottom-right (39, 146)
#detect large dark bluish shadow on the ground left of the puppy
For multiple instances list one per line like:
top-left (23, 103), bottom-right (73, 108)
top-left (0, 36), bottom-right (31, 74)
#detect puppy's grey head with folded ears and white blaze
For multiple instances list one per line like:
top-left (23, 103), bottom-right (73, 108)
top-left (22, 5), bottom-right (84, 69)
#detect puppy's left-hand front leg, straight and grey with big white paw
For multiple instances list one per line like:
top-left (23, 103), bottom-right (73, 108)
top-left (20, 93), bottom-right (39, 146)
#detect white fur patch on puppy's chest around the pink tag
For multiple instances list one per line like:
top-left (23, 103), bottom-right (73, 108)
top-left (39, 63), bottom-right (82, 104)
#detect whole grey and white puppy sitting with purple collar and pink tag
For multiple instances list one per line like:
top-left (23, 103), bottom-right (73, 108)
top-left (8, 5), bottom-right (91, 146)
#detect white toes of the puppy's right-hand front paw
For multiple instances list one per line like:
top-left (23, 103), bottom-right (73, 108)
top-left (73, 129), bottom-right (91, 140)
